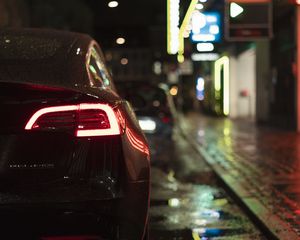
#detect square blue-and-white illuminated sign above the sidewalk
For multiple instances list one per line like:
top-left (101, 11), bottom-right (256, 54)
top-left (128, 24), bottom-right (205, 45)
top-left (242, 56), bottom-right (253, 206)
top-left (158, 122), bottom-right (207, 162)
top-left (191, 11), bottom-right (221, 42)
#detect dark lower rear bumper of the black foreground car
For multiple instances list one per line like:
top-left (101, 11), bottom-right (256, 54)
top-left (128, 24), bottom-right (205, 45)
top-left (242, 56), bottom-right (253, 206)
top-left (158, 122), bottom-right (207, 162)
top-left (0, 182), bottom-right (149, 239)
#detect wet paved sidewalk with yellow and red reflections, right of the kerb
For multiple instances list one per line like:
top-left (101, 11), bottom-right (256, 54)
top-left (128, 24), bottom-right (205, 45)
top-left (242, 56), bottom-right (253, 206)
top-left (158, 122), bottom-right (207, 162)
top-left (179, 113), bottom-right (300, 240)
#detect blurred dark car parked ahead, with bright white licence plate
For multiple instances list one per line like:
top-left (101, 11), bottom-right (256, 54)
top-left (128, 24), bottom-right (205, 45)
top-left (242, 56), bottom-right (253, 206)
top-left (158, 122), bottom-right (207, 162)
top-left (116, 81), bottom-right (176, 163)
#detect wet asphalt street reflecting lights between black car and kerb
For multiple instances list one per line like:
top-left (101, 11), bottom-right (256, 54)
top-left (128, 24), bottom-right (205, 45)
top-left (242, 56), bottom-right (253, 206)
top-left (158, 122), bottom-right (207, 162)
top-left (149, 126), bottom-right (267, 240)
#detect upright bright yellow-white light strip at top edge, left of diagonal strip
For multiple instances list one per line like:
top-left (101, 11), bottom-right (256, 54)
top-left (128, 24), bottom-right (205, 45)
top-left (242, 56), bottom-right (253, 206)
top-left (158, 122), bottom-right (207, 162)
top-left (167, 0), bottom-right (179, 54)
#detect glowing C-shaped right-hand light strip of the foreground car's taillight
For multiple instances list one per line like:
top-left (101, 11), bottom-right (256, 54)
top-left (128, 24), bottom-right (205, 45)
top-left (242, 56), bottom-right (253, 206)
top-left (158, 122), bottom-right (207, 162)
top-left (76, 103), bottom-right (120, 137)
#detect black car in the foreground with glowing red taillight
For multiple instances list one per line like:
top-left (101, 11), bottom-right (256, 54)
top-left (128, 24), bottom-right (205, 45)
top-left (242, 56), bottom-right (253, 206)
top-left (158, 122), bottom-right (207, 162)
top-left (0, 29), bottom-right (150, 239)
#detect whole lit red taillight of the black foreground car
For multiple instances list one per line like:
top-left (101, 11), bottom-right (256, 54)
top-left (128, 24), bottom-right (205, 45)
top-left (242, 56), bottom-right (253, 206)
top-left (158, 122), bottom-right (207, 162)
top-left (25, 103), bottom-right (120, 137)
